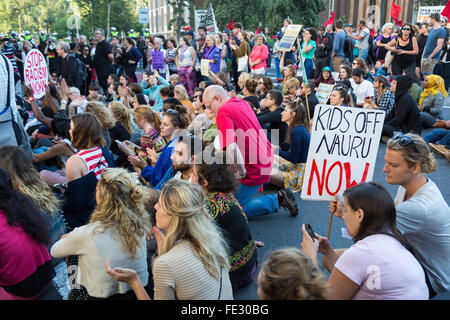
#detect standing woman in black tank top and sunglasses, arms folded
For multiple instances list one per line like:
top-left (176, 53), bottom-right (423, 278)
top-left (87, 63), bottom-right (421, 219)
top-left (385, 23), bottom-right (419, 75)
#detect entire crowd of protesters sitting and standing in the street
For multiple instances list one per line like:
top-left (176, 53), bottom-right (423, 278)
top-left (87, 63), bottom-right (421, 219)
top-left (0, 14), bottom-right (450, 300)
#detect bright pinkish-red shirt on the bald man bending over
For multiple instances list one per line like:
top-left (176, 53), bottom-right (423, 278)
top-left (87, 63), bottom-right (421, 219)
top-left (216, 97), bottom-right (273, 186)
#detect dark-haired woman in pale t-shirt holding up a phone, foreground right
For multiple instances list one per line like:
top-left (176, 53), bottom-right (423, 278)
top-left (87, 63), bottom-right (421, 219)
top-left (301, 182), bottom-right (429, 300)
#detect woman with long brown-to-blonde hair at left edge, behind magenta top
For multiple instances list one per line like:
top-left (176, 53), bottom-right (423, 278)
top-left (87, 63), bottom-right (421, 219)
top-left (0, 146), bottom-right (66, 254)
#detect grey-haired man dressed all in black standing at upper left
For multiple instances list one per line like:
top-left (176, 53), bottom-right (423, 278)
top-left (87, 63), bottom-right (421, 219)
top-left (93, 28), bottom-right (114, 92)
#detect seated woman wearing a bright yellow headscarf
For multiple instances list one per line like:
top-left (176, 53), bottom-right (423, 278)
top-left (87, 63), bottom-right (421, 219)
top-left (419, 74), bottom-right (448, 128)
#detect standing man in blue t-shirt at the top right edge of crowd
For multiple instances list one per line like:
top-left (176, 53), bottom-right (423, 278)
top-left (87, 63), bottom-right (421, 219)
top-left (421, 13), bottom-right (446, 74)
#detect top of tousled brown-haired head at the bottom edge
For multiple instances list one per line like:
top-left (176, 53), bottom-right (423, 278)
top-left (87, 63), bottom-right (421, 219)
top-left (258, 248), bottom-right (329, 300)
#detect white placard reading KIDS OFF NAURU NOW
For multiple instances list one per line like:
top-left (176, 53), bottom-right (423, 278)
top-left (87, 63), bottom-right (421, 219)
top-left (301, 104), bottom-right (385, 201)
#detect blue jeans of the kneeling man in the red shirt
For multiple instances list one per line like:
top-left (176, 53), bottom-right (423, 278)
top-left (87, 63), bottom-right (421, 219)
top-left (237, 183), bottom-right (278, 218)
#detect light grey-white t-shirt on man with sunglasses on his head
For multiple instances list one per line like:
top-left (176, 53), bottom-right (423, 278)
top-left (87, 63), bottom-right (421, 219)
top-left (395, 178), bottom-right (450, 293)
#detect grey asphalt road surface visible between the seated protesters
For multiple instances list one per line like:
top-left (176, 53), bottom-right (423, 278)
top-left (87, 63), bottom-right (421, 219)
top-left (41, 61), bottom-right (450, 300)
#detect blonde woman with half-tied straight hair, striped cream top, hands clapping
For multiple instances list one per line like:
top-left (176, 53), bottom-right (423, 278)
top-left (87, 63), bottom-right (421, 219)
top-left (107, 179), bottom-right (233, 300)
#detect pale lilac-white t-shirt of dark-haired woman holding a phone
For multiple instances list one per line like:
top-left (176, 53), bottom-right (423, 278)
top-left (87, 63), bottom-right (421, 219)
top-left (334, 234), bottom-right (428, 300)
